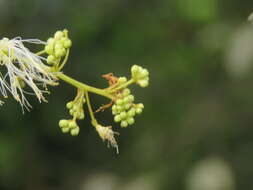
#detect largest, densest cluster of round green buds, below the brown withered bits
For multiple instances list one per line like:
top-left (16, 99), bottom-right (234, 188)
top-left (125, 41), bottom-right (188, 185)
top-left (112, 88), bottom-right (144, 127)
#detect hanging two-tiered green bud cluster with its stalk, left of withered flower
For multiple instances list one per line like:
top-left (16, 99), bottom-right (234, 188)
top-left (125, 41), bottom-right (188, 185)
top-left (59, 91), bottom-right (85, 136)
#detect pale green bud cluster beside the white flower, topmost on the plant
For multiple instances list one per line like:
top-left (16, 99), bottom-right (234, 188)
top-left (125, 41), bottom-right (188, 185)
top-left (45, 30), bottom-right (72, 64)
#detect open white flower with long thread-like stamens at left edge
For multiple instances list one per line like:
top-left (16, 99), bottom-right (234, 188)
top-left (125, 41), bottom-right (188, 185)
top-left (0, 37), bottom-right (56, 110)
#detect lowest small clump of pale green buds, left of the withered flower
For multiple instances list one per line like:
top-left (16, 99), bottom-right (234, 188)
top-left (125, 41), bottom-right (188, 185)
top-left (59, 119), bottom-right (80, 136)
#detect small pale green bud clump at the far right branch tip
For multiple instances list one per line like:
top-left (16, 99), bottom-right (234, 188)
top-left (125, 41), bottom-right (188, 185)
top-left (131, 65), bottom-right (149, 88)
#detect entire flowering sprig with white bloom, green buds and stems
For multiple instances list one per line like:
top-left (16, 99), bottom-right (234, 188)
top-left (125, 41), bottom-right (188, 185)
top-left (0, 30), bottom-right (149, 152)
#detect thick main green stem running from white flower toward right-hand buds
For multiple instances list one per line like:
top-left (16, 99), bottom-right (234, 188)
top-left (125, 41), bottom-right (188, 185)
top-left (54, 72), bottom-right (114, 99)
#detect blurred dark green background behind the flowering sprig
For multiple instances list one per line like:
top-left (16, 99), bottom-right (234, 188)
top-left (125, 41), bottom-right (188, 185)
top-left (0, 0), bottom-right (253, 190)
